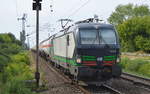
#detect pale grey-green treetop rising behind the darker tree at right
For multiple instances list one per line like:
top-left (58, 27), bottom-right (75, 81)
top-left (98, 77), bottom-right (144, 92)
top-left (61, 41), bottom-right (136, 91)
top-left (108, 4), bottom-right (150, 25)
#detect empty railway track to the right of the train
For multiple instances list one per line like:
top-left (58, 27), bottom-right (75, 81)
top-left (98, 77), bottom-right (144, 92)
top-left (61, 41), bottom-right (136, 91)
top-left (121, 72), bottom-right (150, 91)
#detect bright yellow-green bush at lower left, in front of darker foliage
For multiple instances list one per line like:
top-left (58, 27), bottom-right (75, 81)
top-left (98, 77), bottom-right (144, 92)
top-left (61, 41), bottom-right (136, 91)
top-left (0, 52), bottom-right (34, 94)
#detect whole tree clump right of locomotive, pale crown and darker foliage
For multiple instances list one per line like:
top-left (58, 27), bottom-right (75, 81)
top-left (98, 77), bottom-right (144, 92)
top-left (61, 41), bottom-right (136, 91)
top-left (108, 4), bottom-right (150, 53)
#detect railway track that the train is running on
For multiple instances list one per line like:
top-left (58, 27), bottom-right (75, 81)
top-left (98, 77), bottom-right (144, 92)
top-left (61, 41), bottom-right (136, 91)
top-left (42, 58), bottom-right (123, 94)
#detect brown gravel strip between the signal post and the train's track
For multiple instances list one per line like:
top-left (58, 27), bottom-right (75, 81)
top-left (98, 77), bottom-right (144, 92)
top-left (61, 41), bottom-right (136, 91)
top-left (32, 53), bottom-right (84, 94)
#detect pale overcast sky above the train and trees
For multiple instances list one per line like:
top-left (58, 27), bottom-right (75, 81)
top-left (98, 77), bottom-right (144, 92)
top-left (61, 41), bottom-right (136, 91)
top-left (0, 0), bottom-right (150, 45)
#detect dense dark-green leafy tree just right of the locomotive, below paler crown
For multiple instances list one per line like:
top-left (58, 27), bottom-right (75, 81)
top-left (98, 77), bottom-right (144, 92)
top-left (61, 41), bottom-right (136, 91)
top-left (117, 16), bottom-right (150, 52)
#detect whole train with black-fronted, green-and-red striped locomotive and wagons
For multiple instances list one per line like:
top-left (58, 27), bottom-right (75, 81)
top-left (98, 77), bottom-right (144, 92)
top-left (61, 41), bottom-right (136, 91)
top-left (34, 19), bottom-right (121, 81)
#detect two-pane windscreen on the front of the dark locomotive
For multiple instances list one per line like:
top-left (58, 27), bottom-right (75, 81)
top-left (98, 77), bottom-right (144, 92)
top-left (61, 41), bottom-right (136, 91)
top-left (79, 28), bottom-right (117, 44)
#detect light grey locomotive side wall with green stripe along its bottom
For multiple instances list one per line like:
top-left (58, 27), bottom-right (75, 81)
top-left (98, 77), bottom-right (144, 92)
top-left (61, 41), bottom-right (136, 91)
top-left (53, 32), bottom-right (75, 69)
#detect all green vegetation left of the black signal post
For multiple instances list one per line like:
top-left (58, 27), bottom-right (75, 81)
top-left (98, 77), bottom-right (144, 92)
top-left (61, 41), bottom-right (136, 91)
top-left (0, 33), bottom-right (34, 94)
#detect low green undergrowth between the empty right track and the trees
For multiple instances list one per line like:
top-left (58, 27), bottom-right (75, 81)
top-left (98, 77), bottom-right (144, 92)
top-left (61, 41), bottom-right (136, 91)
top-left (120, 57), bottom-right (150, 78)
